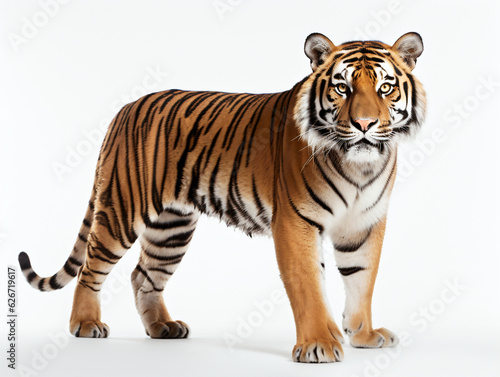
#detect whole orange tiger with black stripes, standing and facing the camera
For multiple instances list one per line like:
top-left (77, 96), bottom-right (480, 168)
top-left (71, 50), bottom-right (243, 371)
top-left (19, 32), bottom-right (426, 363)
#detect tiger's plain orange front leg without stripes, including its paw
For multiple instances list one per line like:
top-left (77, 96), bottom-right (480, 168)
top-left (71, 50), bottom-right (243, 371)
top-left (272, 210), bottom-right (344, 363)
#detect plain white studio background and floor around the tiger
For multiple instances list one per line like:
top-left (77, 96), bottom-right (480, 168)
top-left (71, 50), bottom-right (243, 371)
top-left (0, 0), bottom-right (500, 377)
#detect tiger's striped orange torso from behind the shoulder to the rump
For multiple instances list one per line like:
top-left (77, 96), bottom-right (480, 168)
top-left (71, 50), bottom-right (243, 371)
top-left (98, 90), bottom-right (294, 234)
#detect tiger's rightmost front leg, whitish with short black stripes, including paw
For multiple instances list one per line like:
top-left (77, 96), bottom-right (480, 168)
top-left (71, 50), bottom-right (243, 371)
top-left (334, 218), bottom-right (398, 348)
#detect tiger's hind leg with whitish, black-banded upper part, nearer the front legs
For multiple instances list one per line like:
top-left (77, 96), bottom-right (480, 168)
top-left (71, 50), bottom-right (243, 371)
top-left (132, 209), bottom-right (199, 338)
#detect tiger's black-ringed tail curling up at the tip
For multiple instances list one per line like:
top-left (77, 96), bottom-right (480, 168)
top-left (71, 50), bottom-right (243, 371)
top-left (19, 188), bottom-right (95, 292)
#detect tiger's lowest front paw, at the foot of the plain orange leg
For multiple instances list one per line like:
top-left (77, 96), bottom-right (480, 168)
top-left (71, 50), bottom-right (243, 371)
top-left (292, 338), bottom-right (344, 363)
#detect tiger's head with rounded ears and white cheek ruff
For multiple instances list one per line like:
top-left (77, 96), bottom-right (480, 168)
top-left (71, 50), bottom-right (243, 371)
top-left (295, 33), bottom-right (426, 164)
